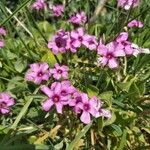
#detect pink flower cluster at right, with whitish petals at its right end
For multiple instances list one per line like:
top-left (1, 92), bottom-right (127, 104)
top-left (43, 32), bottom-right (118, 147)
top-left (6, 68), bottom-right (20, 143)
top-left (97, 32), bottom-right (146, 69)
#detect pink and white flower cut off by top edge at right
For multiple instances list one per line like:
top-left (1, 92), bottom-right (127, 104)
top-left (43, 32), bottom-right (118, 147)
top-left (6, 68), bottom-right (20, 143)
top-left (118, 0), bottom-right (140, 10)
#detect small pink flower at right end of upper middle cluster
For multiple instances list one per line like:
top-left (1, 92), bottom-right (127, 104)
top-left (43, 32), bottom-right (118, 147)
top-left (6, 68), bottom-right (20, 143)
top-left (83, 35), bottom-right (98, 50)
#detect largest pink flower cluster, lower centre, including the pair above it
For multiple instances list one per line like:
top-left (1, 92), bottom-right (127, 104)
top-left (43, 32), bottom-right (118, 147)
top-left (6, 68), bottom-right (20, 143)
top-left (25, 63), bottom-right (111, 124)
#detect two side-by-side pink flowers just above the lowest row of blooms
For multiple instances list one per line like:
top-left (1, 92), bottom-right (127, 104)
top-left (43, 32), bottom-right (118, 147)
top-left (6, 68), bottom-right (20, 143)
top-left (25, 63), bottom-right (69, 84)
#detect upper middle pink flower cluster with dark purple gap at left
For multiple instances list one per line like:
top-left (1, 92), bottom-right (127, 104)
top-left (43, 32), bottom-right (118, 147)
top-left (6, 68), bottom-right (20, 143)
top-left (48, 27), bottom-right (97, 55)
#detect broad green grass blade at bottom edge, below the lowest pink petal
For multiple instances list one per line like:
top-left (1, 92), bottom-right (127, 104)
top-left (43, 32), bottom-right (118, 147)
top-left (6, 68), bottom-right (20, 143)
top-left (66, 122), bottom-right (92, 150)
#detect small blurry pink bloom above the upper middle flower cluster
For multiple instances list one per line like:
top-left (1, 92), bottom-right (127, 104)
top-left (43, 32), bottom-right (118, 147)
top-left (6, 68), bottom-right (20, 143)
top-left (69, 11), bottom-right (87, 25)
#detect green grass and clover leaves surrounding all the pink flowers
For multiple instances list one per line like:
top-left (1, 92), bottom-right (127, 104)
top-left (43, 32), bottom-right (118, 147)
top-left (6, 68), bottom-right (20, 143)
top-left (0, 0), bottom-right (150, 150)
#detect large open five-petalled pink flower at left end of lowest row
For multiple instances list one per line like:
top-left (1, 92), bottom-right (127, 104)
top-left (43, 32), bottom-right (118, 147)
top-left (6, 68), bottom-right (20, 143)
top-left (41, 82), bottom-right (69, 114)
